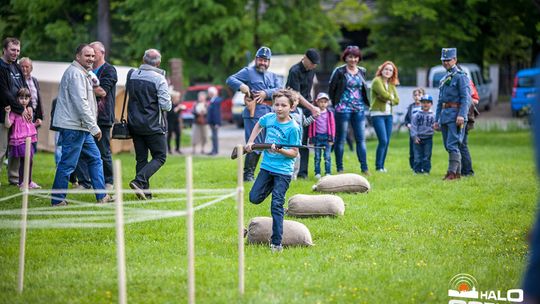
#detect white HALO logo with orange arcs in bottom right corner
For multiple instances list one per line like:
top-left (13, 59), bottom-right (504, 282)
top-left (448, 273), bottom-right (523, 304)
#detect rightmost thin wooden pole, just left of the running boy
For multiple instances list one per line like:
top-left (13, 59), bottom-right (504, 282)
top-left (236, 145), bottom-right (244, 295)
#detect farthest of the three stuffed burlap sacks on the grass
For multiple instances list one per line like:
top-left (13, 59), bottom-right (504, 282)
top-left (313, 173), bottom-right (371, 193)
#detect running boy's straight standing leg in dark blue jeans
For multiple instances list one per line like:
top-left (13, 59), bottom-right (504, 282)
top-left (270, 173), bottom-right (291, 245)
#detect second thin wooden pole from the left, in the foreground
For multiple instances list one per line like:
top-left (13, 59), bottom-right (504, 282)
top-left (114, 159), bottom-right (127, 304)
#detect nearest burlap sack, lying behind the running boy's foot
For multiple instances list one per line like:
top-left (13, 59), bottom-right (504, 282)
top-left (247, 217), bottom-right (313, 246)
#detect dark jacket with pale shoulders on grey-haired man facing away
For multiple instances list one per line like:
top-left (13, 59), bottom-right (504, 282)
top-left (127, 64), bottom-right (172, 135)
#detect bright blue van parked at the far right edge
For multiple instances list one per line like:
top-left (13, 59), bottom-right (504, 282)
top-left (510, 68), bottom-right (540, 116)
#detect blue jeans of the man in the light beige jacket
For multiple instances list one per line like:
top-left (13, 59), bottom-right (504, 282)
top-left (51, 129), bottom-right (105, 205)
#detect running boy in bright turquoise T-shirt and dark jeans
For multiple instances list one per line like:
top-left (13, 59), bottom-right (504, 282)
top-left (246, 90), bottom-right (302, 252)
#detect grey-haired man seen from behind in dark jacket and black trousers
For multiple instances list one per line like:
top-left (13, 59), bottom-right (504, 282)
top-left (126, 49), bottom-right (172, 200)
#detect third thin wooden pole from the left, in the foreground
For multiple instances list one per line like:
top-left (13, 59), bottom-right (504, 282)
top-left (186, 155), bottom-right (195, 304)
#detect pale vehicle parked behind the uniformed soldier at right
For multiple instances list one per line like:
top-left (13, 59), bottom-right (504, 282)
top-left (428, 63), bottom-right (494, 111)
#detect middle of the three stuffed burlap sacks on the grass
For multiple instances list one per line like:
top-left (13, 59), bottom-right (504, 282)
top-left (287, 194), bottom-right (345, 217)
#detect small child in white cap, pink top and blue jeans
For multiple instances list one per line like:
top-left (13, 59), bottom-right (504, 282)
top-left (308, 93), bottom-right (336, 179)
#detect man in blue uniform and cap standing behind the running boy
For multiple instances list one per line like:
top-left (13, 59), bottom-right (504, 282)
top-left (227, 46), bottom-right (283, 181)
